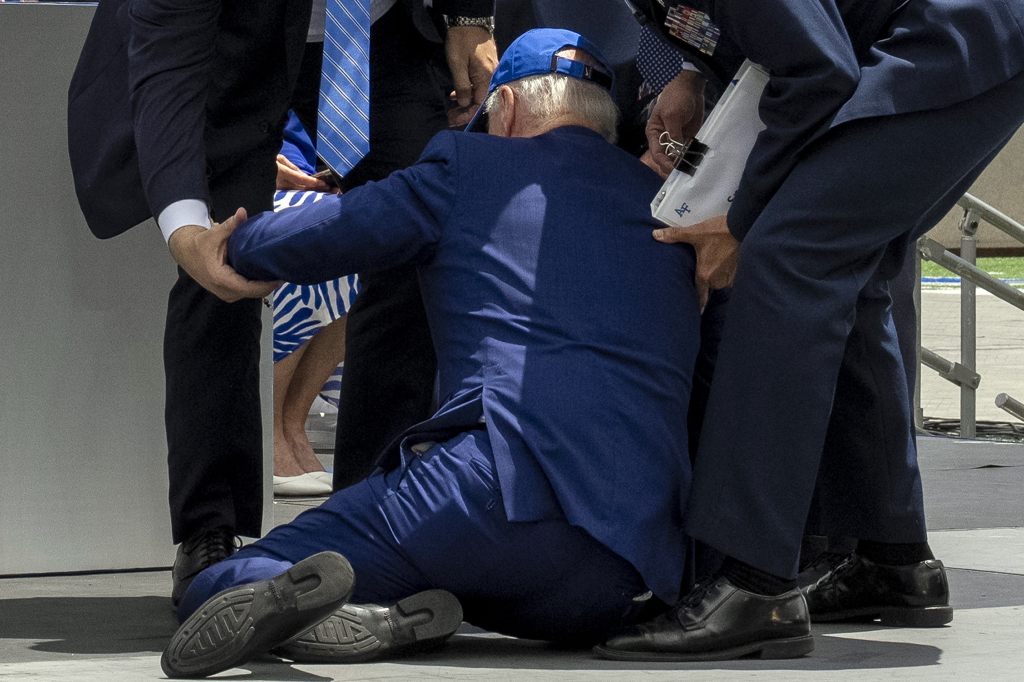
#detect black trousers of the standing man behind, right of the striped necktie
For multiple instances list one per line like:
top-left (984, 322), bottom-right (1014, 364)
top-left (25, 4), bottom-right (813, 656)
top-left (334, 3), bottom-right (452, 489)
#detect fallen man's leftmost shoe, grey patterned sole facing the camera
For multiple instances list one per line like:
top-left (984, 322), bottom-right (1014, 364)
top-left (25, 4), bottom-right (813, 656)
top-left (160, 552), bottom-right (355, 677)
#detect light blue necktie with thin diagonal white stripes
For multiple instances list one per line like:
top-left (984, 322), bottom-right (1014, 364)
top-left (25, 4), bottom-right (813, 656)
top-left (316, 0), bottom-right (370, 176)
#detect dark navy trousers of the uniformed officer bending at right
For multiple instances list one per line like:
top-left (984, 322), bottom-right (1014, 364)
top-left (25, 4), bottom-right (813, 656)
top-left (687, 70), bottom-right (1024, 577)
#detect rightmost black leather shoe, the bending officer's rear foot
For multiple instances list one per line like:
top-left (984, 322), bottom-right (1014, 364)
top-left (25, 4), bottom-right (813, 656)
top-left (804, 553), bottom-right (953, 628)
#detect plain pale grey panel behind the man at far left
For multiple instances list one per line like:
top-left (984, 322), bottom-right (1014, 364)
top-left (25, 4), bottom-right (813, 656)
top-left (0, 4), bottom-right (271, 574)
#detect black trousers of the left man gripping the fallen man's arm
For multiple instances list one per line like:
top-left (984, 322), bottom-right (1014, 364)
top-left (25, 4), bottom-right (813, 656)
top-left (164, 148), bottom-right (280, 543)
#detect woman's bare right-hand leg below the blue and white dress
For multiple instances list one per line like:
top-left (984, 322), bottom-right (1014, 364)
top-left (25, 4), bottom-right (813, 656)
top-left (275, 317), bottom-right (345, 475)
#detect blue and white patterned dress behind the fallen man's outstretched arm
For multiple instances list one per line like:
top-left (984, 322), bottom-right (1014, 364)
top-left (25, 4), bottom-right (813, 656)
top-left (272, 190), bottom-right (358, 360)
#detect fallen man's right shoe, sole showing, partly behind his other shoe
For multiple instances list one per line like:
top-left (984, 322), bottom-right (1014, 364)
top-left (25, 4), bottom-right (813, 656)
top-left (273, 590), bottom-right (462, 664)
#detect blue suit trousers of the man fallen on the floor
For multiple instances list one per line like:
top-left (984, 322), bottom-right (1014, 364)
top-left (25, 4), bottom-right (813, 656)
top-left (178, 430), bottom-right (647, 641)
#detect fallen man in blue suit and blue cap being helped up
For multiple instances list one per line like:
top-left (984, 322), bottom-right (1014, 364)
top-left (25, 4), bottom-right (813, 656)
top-left (162, 29), bottom-right (698, 677)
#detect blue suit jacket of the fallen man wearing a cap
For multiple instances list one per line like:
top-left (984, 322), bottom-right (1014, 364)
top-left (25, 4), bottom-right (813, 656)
top-left (229, 127), bottom-right (698, 602)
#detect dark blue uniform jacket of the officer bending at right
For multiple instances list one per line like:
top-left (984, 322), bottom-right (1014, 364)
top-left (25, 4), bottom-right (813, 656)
top-left (651, 0), bottom-right (1024, 238)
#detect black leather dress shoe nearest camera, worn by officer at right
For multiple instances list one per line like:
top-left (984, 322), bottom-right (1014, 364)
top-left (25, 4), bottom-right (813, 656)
top-left (594, 578), bottom-right (814, 660)
